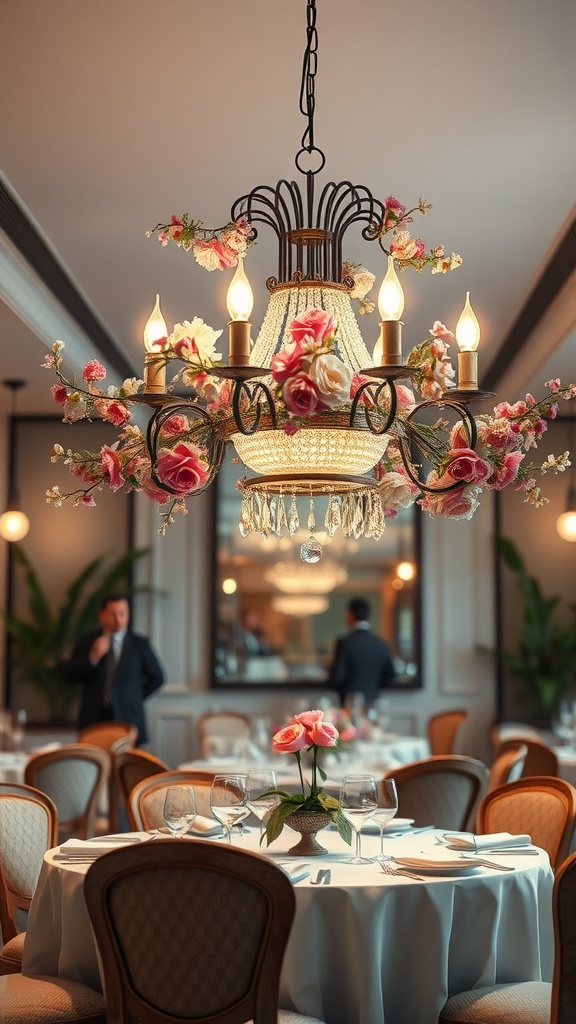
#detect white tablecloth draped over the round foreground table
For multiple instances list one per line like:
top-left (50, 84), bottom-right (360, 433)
top-left (24, 828), bottom-right (553, 1024)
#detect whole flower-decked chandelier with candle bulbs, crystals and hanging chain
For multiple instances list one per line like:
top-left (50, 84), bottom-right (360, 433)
top-left (44, 0), bottom-right (576, 562)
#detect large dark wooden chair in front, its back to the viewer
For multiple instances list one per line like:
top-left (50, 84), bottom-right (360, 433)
top-left (84, 840), bottom-right (327, 1024)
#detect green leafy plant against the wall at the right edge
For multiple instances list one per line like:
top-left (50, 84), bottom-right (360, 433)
top-left (492, 537), bottom-right (576, 718)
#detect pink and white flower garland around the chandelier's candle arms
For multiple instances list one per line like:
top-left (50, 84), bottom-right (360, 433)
top-left (44, 309), bottom-right (576, 534)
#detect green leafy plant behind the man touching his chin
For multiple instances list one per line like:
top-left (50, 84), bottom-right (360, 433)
top-left (3, 545), bottom-right (150, 723)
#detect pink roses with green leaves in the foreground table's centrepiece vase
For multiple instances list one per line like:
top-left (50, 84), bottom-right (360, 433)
top-left (262, 711), bottom-right (352, 846)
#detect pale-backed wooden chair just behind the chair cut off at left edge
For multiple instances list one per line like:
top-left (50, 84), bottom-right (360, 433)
top-left (25, 743), bottom-right (109, 842)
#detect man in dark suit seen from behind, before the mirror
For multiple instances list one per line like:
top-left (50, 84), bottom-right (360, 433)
top-left (328, 597), bottom-right (396, 705)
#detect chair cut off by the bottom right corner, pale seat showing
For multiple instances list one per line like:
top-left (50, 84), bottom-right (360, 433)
top-left (439, 853), bottom-right (576, 1024)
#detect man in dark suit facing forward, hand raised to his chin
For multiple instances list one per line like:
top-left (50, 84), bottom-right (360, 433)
top-left (66, 594), bottom-right (164, 745)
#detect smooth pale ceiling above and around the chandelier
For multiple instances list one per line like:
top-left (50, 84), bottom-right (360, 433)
top-left (0, 0), bottom-right (576, 412)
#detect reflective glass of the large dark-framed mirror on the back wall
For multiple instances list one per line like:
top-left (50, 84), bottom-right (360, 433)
top-left (213, 456), bottom-right (421, 688)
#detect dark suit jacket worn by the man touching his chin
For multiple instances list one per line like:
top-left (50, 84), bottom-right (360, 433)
top-left (66, 630), bottom-right (164, 744)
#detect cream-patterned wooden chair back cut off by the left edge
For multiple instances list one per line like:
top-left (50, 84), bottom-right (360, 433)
top-left (0, 782), bottom-right (58, 975)
